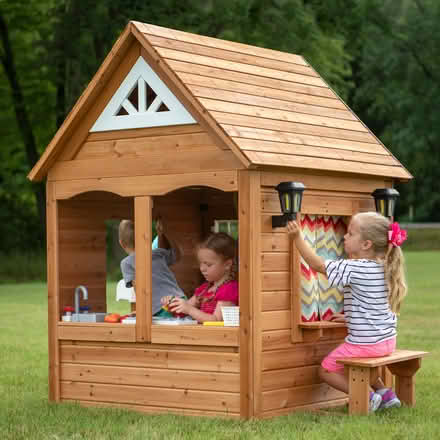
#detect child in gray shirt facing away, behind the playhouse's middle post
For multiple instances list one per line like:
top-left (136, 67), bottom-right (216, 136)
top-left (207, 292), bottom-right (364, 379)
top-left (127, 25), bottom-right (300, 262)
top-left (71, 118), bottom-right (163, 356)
top-left (119, 219), bottom-right (185, 315)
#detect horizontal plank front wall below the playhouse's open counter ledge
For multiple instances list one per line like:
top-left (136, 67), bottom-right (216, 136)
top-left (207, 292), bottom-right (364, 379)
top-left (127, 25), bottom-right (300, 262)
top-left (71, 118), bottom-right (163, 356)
top-left (60, 343), bottom-right (240, 416)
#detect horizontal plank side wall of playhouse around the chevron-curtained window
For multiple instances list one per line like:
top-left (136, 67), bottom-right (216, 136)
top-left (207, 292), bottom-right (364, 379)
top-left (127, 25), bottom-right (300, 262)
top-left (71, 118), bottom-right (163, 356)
top-left (255, 172), bottom-right (366, 417)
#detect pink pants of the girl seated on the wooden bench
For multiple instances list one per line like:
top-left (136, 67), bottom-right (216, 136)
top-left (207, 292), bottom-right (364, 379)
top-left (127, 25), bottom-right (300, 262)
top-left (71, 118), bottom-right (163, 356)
top-left (321, 337), bottom-right (396, 374)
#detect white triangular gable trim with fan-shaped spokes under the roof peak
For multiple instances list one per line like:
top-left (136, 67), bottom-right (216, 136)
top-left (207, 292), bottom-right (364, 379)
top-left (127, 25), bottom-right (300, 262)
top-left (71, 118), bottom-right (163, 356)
top-left (90, 57), bottom-right (196, 132)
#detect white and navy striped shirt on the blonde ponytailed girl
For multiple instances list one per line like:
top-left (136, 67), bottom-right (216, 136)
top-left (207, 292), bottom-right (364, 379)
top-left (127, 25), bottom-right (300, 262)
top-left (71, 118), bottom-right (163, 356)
top-left (325, 259), bottom-right (397, 345)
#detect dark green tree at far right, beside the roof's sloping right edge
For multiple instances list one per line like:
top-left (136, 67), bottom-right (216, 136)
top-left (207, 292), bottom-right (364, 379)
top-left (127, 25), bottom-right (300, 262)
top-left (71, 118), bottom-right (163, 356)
top-left (353, 0), bottom-right (440, 221)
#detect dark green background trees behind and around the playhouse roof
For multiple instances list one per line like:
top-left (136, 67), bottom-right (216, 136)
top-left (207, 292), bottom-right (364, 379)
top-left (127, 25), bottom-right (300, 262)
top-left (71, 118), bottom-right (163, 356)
top-left (0, 0), bottom-right (440, 251)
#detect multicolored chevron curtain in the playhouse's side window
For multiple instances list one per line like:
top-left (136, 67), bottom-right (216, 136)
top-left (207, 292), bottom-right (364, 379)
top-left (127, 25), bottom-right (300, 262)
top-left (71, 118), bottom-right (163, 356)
top-left (300, 214), bottom-right (347, 322)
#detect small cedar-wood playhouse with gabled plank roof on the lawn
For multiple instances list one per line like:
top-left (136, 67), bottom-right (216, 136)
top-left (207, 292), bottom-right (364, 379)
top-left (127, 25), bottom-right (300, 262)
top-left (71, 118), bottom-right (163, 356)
top-left (29, 22), bottom-right (411, 418)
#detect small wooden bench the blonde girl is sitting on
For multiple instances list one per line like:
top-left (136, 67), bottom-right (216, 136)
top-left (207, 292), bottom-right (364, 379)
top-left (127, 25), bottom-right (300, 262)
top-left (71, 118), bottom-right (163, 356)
top-left (337, 350), bottom-right (428, 414)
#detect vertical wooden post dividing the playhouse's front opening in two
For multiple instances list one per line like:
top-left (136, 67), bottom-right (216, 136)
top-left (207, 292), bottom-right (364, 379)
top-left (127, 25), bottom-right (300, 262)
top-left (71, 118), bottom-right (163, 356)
top-left (134, 196), bottom-right (153, 342)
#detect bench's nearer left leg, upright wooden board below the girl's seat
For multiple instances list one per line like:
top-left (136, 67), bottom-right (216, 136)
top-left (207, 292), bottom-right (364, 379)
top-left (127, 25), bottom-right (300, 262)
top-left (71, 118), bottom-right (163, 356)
top-left (348, 366), bottom-right (378, 415)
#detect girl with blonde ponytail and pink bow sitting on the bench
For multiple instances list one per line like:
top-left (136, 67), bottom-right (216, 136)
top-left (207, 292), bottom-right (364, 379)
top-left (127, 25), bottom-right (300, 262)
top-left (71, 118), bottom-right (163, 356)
top-left (287, 212), bottom-right (407, 411)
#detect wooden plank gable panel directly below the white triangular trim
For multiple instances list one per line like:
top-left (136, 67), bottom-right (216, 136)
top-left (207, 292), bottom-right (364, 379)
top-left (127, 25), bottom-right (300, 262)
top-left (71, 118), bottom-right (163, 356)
top-left (49, 124), bottom-right (243, 181)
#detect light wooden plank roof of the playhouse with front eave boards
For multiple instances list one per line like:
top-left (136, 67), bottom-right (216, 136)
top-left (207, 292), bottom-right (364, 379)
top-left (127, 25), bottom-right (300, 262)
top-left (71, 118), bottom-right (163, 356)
top-left (29, 22), bottom-right (412, 180)
